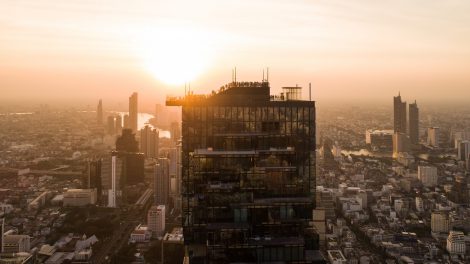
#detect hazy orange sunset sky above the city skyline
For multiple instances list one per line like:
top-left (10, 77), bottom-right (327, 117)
top-left (0, 0), bottom-right (470, 109)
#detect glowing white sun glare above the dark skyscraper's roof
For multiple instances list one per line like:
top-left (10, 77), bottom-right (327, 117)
top-left (133, 25), bottom-right (214, 85)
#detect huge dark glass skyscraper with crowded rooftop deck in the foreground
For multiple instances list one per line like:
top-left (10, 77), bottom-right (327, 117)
top-left (166, 82), bottom-right (318, 263)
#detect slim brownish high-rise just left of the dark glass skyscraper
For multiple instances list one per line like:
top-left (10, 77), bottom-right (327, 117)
top-left (154, 158), bottom-right (170, 208)
